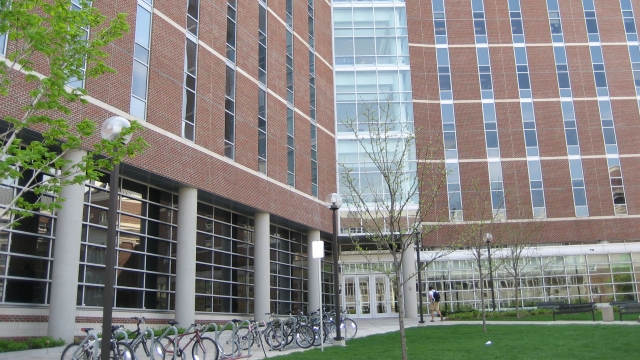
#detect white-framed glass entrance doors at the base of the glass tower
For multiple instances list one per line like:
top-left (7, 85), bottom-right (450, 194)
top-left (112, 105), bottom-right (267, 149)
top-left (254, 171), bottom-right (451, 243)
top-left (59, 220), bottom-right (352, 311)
top-left (342, 274), bottom-right (397, 318)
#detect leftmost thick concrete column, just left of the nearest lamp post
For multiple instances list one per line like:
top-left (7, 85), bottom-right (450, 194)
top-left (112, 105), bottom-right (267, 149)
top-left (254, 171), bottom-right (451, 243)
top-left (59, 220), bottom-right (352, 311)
top-left (47, 150), bottom-right (87, 343)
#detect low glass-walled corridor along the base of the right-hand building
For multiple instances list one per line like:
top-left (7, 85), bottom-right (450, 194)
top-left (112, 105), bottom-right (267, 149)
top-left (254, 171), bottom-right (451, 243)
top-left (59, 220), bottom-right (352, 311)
top-left (416, 243), bottom-right (640, 310)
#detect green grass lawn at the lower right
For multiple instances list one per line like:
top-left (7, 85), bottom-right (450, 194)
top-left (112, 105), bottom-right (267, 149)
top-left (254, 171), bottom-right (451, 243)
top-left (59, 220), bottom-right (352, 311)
top-left (269, 323), bottom-right (640, 360)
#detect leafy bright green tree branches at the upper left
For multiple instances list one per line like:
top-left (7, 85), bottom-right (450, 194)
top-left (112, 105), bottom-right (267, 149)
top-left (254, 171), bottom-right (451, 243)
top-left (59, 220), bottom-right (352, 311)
top-left (0, 0), bottom-right (146, 231)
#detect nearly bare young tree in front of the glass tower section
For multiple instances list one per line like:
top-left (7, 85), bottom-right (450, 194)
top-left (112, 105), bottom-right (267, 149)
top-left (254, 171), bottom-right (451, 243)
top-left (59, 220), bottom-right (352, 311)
top-left (339, 101), bottom-right (448, 359)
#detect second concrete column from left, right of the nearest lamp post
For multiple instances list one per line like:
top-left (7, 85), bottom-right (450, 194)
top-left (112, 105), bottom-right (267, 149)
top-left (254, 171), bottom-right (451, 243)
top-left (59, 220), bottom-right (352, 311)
top-left (175, 187), bottom-right (198, 328)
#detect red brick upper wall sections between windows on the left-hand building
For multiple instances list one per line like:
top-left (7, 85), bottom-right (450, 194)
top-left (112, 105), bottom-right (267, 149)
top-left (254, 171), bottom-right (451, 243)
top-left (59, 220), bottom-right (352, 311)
top-left (0, 0), bottom-right (336, 232)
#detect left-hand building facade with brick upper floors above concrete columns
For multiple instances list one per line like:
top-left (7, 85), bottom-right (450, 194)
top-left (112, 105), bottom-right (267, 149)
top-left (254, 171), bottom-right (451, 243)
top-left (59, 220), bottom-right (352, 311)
top-left (0, 0), bottom-right (336, 341)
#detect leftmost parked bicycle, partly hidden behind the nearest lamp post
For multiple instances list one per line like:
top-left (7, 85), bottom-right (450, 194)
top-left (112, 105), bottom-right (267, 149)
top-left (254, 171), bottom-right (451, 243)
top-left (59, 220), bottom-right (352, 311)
top-left (60, 325), bottom-right (135, 360)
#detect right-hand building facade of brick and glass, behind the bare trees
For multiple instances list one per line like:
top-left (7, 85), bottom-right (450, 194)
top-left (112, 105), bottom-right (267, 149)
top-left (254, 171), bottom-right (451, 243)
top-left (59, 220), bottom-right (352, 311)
top-left (334, 0), bottom-right (640, 316)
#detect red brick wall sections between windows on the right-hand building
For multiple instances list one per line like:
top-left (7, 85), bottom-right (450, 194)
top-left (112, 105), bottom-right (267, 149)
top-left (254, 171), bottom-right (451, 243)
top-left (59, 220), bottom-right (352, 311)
top-left (407, 0), bottom-right (640, 245)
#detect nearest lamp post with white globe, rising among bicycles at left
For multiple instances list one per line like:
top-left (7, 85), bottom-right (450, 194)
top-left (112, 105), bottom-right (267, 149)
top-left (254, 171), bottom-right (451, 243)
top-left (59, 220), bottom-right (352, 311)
top-left (100, 116), bottom-right (131, 360)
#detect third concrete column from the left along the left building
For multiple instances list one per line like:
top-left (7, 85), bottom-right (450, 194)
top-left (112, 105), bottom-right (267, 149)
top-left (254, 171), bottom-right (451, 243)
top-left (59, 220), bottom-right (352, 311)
top-left (253, 213), bottom-right (271, 320)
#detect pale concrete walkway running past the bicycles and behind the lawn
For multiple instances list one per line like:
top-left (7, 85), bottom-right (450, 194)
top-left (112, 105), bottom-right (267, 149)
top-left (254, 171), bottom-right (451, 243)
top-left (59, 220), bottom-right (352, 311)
top-left (0, 316), bottom-right (638, 360)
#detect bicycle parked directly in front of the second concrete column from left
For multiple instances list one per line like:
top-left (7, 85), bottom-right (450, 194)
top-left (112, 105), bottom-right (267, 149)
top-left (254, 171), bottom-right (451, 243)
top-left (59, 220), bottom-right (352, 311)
top-left (158, 321), bottom-right (219, 360)
